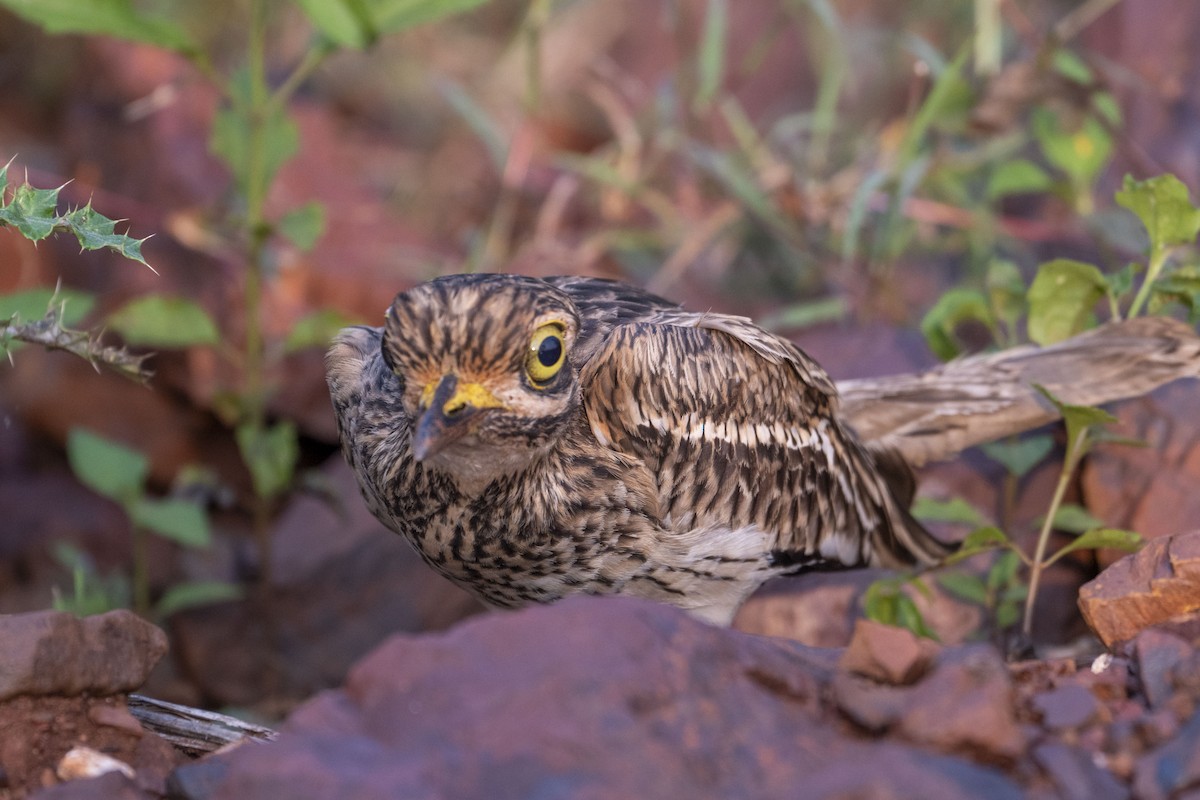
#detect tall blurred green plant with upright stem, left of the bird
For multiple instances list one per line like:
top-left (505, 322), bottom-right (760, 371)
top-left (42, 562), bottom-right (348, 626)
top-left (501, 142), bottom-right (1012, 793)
top-left (0, 0), bottom-right (485, 585)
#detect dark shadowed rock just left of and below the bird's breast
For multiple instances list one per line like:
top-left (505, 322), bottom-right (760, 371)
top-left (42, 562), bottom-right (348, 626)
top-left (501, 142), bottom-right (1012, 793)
top-left (172, 456), bottom-right (481, 705)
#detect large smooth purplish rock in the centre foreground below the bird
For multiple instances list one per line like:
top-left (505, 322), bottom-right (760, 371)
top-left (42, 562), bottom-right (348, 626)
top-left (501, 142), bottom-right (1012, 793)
top-left (184, 597), bottom-right (1020, 800)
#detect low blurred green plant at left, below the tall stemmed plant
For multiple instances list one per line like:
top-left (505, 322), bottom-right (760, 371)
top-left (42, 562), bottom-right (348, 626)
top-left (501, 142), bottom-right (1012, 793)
top-left (63, 428), bottom-right (240, 618)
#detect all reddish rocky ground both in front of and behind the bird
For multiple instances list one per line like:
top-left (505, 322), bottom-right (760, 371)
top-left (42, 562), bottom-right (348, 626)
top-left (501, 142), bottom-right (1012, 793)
top-left (0, 0), bottom-right (1200, 800)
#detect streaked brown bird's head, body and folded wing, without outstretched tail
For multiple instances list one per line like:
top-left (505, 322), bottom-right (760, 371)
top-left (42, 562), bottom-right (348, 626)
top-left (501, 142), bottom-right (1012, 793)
top-left (326, 273), bottom-right (950, 625)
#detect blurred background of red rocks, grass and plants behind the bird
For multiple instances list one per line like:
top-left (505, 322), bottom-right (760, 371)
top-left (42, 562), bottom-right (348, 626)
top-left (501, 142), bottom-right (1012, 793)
top-left (0, 0), bottom-right (1200, 716)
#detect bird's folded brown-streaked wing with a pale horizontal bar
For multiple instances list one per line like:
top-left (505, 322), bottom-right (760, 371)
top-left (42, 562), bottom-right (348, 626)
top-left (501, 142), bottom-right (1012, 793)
top-left (581, 309), bottom-right (944, 566)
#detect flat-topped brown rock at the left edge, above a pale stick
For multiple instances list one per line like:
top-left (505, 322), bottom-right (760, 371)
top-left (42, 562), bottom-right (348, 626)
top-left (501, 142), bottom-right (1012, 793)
top-left (0, 610), bottom-right (167, 700)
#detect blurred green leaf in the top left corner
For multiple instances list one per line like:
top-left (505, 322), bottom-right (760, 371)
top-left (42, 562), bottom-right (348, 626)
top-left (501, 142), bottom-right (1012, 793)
top-left (0, 0), bottom-right (197, 54)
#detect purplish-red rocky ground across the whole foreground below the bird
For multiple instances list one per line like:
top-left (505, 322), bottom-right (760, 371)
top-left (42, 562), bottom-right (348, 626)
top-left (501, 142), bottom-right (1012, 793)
top-left (0, 533), bottom-right (1200, 800)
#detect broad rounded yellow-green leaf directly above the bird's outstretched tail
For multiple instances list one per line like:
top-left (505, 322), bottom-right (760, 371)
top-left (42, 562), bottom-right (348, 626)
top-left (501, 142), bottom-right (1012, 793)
top-left (1028, 258), bottom-right (1108, 345)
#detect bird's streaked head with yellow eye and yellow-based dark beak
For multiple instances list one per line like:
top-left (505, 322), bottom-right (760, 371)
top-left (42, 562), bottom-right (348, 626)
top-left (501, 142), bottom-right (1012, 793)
top-left (383, 275), bottom-right (580, 483)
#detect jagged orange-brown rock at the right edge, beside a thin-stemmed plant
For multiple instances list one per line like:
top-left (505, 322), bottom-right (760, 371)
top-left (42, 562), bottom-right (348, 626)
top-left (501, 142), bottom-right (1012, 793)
top-left (1079, 531), bottom-right (1200, 648)
